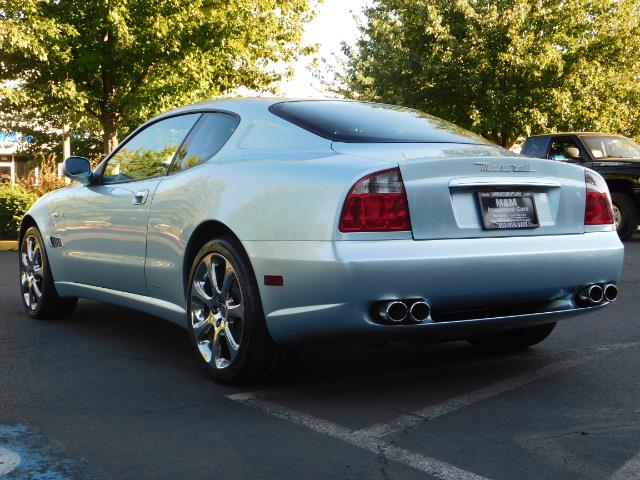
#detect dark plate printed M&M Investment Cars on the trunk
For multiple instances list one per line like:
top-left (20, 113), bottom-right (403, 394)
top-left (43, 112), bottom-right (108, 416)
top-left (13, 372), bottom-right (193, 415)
top-left (478, 191), bottom-right (539, 230)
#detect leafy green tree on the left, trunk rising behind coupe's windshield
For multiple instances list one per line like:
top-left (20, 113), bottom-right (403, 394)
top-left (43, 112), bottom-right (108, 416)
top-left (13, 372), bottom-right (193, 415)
top-left (0, 0), bottom-right (315, 152)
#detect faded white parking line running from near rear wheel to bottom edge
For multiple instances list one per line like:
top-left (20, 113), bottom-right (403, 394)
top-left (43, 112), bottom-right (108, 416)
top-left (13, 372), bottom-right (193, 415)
top-left (227, 393), bottom-right (487, 480)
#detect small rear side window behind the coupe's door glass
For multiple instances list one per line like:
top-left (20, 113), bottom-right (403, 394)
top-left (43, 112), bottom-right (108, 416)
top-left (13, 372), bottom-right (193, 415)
top-left (169, 113), bottom-right (238, 173)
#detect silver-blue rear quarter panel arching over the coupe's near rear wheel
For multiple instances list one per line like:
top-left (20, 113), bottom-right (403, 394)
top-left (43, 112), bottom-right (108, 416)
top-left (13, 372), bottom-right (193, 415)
top-left (145, 149), bottom-right (388, 306)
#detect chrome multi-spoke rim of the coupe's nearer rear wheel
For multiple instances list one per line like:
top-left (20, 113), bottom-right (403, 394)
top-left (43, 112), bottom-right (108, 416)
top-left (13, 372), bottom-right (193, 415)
top-left (190, 253), bottom-right (245, 369)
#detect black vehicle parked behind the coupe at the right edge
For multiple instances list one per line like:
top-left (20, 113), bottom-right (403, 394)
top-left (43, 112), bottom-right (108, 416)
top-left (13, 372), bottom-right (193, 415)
top-left (520, 133), bottom-right (640, 240)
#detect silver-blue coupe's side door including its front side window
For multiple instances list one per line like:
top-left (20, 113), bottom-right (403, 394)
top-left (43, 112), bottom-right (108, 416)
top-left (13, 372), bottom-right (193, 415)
top-left (64, 113), bottom-right (201, 295)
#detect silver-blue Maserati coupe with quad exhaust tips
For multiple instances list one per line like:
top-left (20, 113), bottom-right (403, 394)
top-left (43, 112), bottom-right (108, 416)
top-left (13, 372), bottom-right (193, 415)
top-left (19, 99), bottom-right (623, 382)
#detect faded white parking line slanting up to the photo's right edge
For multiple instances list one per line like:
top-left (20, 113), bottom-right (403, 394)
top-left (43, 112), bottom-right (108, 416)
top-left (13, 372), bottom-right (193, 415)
top-left (358, 342), bottom-right (640, 438)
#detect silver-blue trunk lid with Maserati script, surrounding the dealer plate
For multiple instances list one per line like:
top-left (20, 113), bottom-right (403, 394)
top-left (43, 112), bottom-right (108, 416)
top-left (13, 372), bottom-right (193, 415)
top-left (333, 143), bottom-right (585, 240)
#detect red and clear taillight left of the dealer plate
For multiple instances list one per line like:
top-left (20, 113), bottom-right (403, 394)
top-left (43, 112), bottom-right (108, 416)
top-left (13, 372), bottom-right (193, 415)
top-left (340, 168), bottom-right (411, 232)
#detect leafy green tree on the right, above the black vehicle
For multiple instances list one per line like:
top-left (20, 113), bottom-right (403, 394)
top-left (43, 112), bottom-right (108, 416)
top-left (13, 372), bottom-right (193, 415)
top-left (337, 0), bottom-right (640, 147)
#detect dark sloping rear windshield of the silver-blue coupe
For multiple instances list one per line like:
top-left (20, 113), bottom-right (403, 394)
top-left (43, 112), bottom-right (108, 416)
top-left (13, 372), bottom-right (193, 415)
top-left (269, 100), bottom-right (489, 144)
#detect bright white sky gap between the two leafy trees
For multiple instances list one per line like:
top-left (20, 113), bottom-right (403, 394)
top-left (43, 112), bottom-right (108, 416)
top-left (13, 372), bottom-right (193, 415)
top-left (280, 0), bottom-right (371, 98)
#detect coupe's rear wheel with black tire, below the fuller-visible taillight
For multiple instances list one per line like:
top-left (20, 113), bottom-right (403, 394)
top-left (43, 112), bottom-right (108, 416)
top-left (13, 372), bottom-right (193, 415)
top-left (187, 238), bottom-right (285, 384)
